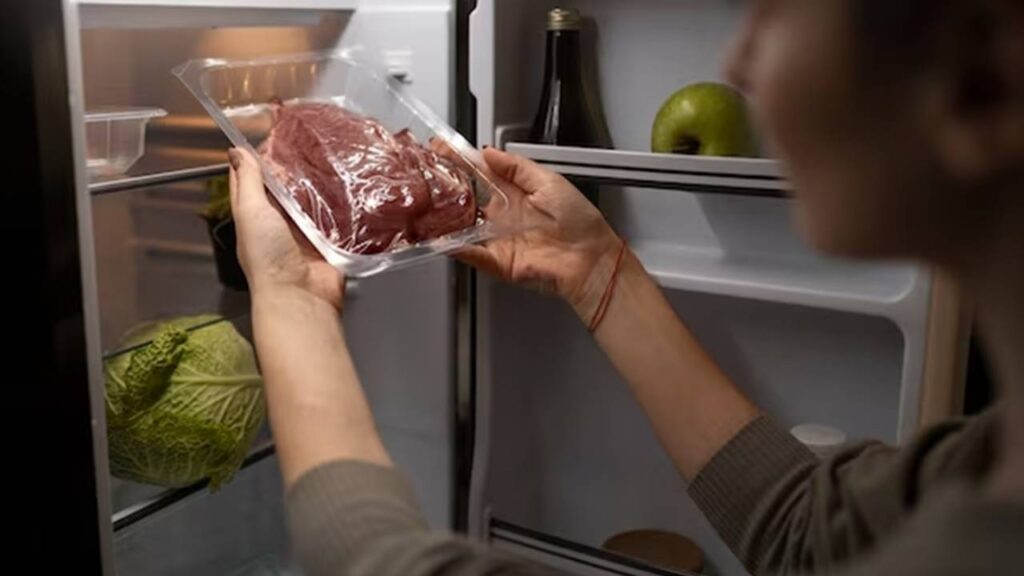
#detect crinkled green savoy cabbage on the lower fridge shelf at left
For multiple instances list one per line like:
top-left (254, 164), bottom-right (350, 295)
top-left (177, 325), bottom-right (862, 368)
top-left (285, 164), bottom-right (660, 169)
top-left (104, 316), bottom-right (264, 489)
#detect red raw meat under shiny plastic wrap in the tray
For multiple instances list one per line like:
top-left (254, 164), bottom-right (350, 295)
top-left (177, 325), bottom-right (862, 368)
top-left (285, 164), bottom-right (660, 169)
top-left (260, 102), bottom-right (476, 254)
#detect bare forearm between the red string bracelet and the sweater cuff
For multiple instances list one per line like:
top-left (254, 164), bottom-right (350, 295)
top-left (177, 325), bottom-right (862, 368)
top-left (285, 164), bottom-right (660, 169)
top-left (578, 251), bottom-right (758, 480)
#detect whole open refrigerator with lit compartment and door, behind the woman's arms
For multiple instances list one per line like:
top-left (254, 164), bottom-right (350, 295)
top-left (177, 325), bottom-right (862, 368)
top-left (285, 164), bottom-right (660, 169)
top-left (16, 0), bottom-right (970, 576)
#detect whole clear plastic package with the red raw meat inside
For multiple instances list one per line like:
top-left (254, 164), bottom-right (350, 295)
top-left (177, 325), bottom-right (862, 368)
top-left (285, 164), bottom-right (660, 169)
top-left (174, 52), bottom-right (508, 277)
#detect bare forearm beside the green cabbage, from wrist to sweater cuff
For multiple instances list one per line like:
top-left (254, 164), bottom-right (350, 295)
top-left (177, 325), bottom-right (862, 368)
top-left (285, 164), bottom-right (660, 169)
top-left (253, 289), bottom-right (391, 487)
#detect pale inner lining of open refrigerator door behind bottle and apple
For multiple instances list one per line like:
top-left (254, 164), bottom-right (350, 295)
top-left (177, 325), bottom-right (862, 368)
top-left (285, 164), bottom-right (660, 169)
top-left (470, 0), bottom-right (931, 576)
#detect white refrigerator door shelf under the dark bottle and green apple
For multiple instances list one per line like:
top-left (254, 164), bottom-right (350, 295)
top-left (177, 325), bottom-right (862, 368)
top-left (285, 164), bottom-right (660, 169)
top-left (505, 142), bottom-right (786, 198)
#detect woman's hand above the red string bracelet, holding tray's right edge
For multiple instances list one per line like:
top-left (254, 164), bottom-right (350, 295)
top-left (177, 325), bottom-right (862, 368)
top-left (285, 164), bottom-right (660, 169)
top-left (458, 149), bottom-right (621, 322)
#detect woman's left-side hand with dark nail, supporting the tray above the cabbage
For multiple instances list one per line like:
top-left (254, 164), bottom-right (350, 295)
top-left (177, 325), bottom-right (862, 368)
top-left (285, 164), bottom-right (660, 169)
top-left (228, 149), bottom-right (344, 312)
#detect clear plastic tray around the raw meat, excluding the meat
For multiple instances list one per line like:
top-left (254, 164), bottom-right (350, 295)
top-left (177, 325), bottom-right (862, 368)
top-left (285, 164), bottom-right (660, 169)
top-left (174, 52), bottom-right (508, 278)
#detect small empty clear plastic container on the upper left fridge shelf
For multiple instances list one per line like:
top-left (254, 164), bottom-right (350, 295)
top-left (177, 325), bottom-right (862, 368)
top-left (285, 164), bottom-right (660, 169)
top-left (85, 108), bottom-right (167, 180)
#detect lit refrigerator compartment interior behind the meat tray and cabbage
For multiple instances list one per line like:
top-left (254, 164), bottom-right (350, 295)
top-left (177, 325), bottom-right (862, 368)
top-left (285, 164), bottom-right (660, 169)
top-left (80, 0), bottom-right (456, 576)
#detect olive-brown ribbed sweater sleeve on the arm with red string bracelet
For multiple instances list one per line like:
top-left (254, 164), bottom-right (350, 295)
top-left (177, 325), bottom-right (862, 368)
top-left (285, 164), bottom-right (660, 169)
top-left (689, 413), bottom-right (995, 574)
